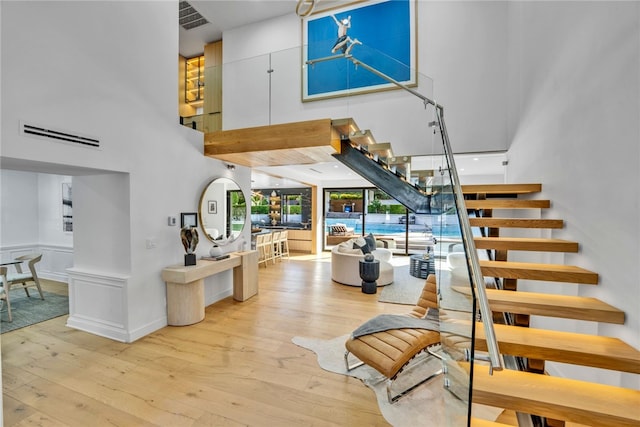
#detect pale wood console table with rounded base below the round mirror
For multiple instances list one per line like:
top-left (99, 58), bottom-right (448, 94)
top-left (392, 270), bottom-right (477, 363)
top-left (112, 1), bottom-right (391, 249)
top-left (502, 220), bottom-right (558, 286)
top-left (162, 251), bottom-right (258, 326)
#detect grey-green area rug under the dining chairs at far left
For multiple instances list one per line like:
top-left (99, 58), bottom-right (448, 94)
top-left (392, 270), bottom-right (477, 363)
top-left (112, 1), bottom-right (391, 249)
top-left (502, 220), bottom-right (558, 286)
top-left (0, 288), bottom-right (69, 334)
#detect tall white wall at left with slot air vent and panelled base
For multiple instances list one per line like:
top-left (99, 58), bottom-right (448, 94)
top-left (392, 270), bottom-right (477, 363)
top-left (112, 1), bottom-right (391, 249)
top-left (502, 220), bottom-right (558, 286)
top-left (0, 1), bottom-right (250, 341)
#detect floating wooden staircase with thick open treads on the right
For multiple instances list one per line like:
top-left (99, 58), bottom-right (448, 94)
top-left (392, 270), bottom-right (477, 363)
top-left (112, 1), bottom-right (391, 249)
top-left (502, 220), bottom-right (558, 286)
top-left (460, 184), bottom-right (640, 426)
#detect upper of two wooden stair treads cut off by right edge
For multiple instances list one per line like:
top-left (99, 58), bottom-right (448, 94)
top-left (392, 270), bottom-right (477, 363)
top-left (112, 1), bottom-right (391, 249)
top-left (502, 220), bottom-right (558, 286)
top-left (476, 324), bottom-right (640, 374)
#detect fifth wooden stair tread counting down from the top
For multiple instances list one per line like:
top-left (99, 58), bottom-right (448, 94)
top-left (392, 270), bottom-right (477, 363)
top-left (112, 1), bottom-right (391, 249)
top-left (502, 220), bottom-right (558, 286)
top-left (480, 260), bottom-right (598, 285)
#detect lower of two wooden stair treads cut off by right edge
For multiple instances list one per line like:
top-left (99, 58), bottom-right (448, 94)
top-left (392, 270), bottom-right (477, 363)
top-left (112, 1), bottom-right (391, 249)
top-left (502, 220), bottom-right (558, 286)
top-left (461, 363), bottom-right (640, 427)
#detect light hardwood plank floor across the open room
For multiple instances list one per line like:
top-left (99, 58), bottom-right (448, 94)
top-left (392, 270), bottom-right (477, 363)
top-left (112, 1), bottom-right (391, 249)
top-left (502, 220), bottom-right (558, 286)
top-left (2, 254), bottom-right (407, 427)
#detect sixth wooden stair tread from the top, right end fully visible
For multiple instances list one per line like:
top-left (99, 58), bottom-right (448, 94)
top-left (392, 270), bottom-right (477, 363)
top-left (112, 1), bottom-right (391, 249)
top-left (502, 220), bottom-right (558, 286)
top-left (454, 287), bottom-right (625, 325)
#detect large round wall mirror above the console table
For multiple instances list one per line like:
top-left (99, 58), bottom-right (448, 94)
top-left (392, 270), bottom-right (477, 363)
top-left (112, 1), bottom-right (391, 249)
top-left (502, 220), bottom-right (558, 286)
top-left (198, 178), bottom-right (247, 244)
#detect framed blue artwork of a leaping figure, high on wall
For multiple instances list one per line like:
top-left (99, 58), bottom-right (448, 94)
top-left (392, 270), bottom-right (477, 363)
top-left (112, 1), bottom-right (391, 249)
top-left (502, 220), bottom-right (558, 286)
top-left (303, 0), bottom-right (416, 100)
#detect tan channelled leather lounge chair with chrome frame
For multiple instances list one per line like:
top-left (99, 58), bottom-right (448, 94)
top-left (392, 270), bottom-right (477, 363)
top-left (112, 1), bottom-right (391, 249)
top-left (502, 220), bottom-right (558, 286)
top-left (344, 274), bottom-right (442, 403)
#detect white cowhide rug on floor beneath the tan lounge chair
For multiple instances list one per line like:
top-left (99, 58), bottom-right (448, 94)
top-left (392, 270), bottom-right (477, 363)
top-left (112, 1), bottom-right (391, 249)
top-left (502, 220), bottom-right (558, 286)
top-left (292, 335), bottom-right (501, 427)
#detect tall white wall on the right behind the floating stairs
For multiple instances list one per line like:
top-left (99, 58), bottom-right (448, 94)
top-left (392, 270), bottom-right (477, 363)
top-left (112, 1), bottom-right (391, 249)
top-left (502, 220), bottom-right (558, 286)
top-left (508, 2), bottom-right (640, 388)
